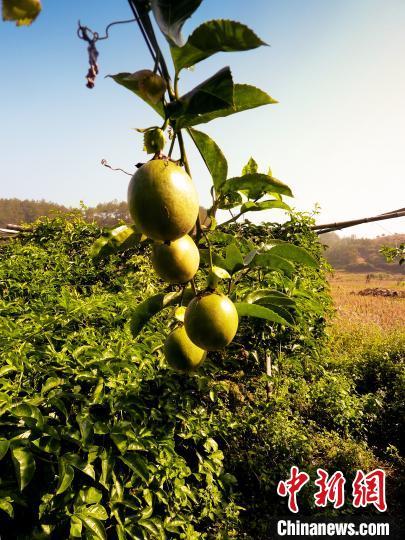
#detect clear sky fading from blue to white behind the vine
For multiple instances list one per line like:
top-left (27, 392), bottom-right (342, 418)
top-left (0, 0), bottom-right (405, 236)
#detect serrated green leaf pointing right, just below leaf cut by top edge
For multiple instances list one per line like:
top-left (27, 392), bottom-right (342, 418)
top-left (171, 20), bottom-right (266, 71)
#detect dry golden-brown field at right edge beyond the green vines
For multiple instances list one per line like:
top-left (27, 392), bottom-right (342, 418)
top-left (329, 272), bottom-right (405, 332)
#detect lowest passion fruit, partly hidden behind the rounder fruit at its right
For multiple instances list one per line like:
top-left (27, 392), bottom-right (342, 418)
top-left (163, 326), bottom-right (207, 373)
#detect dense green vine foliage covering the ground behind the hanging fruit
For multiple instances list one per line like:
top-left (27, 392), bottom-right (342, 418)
top-left (0, 215), bottom-right (405, 539)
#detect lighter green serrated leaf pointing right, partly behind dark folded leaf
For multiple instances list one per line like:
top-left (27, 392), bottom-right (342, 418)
top-left (177, 84), bottom-right (277, 128)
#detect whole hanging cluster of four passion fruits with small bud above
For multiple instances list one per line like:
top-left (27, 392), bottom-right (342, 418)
top-left (128, 150), bottom-right (238, 372)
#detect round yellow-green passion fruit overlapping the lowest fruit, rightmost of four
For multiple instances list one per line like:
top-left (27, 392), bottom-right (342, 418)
top-left (184, 292), bottom-right (239, 351)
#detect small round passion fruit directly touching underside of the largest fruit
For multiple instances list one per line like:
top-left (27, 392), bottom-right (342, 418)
top-left (152, 234), bottom-right (200, 283)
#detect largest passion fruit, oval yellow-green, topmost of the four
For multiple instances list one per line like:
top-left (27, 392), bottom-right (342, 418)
top-left (128, 159), bottom-right (199, 240)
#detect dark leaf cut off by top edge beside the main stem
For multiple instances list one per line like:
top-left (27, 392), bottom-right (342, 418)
top-left (151, 0), bottom-right (202, 47)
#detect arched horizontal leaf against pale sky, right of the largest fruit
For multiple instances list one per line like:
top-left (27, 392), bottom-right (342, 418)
top-left (221, 173), bottom-right (293, 199)
